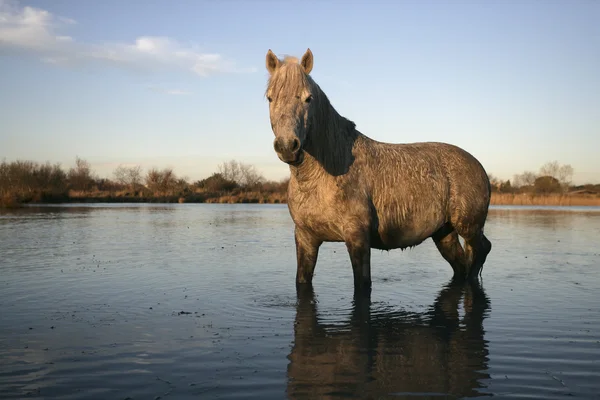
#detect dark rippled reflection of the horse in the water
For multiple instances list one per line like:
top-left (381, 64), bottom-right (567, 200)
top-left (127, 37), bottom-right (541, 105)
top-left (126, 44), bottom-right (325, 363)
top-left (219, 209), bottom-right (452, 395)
top-left (287, 280), bottom-right (490, 399)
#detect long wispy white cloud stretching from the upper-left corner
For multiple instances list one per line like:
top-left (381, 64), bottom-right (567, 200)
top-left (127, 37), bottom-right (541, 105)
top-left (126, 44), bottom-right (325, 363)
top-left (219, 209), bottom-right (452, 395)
top-left (0, 0), bottom-right (255, 77)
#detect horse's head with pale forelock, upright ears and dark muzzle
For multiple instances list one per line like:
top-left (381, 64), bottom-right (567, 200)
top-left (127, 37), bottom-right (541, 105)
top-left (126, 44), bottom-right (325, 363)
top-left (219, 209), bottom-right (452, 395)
top-left (266, 49), bottom-right (318, 165)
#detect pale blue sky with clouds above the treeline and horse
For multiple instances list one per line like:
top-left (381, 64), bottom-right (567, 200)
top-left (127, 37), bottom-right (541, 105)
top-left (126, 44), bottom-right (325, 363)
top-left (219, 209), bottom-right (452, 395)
top-left (0, 0), bottom-right (600, 184)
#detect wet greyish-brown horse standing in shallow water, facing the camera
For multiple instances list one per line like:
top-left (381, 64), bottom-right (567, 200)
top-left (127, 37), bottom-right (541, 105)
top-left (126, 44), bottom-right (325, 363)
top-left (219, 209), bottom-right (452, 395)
top-left (265, 48), bottom-right (492, 291)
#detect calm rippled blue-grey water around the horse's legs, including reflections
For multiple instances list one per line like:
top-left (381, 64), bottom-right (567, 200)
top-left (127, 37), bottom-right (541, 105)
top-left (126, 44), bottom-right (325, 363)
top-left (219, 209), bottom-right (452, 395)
top-left (0, 204), bottom-right (600, 399)
